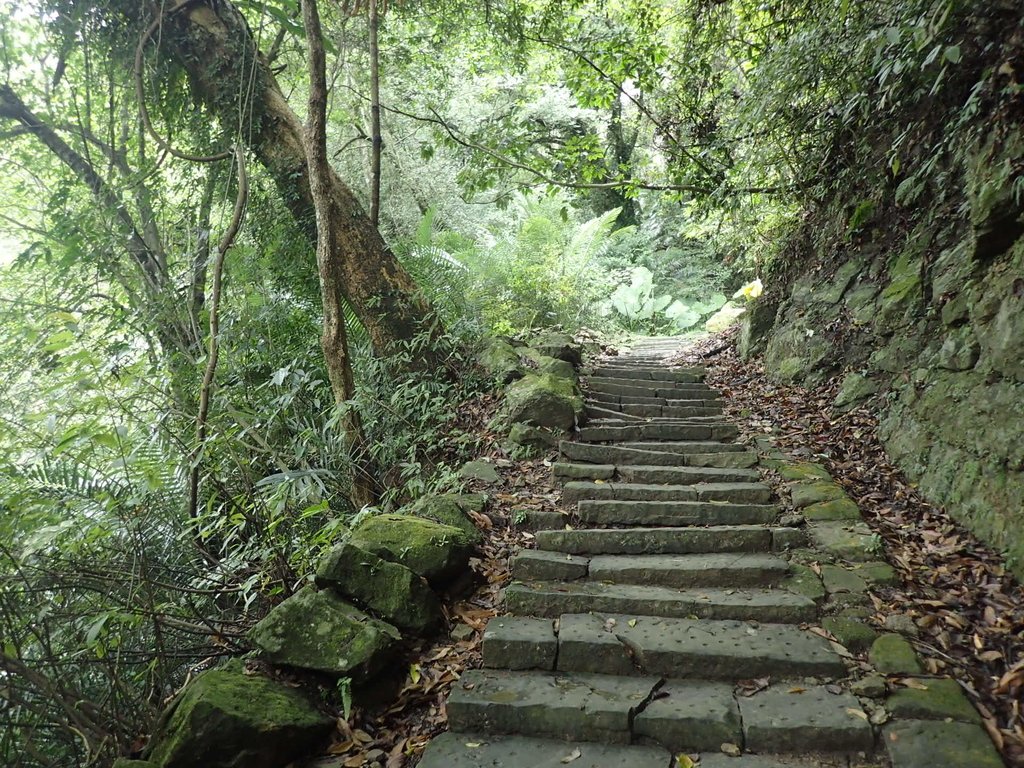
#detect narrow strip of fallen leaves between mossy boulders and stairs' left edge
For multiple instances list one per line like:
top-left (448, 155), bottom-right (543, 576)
top-left (304, 397), bottom-right (560, 768)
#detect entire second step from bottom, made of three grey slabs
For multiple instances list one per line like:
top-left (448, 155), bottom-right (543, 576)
top-left (447, 670), bottom-right (874, 753)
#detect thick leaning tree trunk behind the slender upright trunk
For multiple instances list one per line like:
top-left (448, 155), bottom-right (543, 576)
top-left (154, 0), bottom-right (440, 360)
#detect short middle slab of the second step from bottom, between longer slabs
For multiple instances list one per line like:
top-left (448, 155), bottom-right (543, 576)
top-left (633, 680), bottom-right (742, 753)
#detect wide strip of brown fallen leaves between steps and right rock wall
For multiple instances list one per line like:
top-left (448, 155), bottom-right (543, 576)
top-left (677, 332), bottom-right (1024, 766)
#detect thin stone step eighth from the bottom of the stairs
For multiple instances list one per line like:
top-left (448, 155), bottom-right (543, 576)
top-left (562, 480), bottom-right (774, 504)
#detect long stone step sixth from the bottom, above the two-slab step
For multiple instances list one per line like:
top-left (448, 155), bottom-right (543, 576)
top-left (537, 525), bottom-right (772, 555)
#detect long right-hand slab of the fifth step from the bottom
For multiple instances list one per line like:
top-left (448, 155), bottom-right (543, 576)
top-left (588, 553), bottom-right (790, 589)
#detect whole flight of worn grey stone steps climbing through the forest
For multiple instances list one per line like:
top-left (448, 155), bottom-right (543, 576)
top-left (420, 347), bottom-right (884, 768)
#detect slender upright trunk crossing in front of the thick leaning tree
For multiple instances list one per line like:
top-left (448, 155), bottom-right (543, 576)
top-left (302, 0), bottom-right (377, 509)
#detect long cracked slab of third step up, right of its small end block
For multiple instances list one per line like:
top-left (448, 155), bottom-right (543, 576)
top-left (558, 613), bottom-right (846, 679)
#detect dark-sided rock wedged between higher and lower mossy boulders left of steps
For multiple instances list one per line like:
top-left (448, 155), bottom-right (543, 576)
top-left (316, 542), bottom-right (442, 635)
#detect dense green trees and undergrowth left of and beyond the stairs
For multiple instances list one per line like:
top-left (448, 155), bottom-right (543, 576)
top-left (0, 0), bottom-right (1016, 766)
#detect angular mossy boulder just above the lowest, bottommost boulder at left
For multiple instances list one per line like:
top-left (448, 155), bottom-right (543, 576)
top-left (249, 587), bottom-right (401, 680)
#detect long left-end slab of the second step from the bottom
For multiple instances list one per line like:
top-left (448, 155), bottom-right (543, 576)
top-left (447, 670), bottom-right (659, 743)
